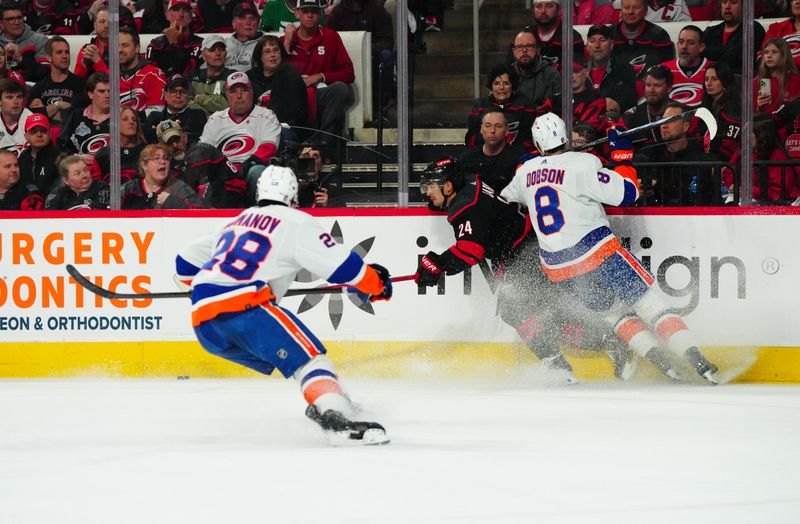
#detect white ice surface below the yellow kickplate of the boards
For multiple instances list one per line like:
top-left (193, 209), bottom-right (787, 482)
top-left (0, 379), bottom-right (800, 524)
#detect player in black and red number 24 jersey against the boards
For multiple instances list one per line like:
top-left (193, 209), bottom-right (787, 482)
top-left (415, 157), bottom-right (677, 383)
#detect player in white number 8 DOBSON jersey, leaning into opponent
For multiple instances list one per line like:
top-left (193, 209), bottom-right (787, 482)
top-left (501, 113), bottom-right (717, 384)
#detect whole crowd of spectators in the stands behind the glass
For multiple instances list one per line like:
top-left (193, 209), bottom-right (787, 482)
top-left (0, 0), bottom-right (800, 210)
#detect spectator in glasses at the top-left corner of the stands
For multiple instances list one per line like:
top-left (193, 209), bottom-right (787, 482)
top-left (0, 2), bottom-right (50, 82)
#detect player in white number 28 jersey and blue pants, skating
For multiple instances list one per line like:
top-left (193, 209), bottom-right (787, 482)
top-left (176, 166), bottom-right (392, 444)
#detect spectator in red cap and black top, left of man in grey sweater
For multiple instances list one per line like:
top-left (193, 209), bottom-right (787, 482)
top-left (147, 0), bottom-right (203, 78)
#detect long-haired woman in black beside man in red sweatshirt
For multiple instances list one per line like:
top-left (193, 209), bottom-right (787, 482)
top-left (247, 35), bottom-right (308, 142)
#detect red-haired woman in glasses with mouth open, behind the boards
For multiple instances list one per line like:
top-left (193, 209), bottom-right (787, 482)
top-left (120, 144), bottom-right (206, 209)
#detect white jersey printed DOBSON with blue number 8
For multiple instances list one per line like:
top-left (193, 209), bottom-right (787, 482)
top-left (500, 152), bottom-right (639, 281)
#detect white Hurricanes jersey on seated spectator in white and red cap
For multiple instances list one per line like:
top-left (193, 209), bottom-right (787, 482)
top-left (200, 106), bottom-right (281, 165)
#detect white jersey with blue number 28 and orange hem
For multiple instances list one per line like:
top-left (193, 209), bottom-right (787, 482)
top-left (175, 205), bottom-right (375, 326)
